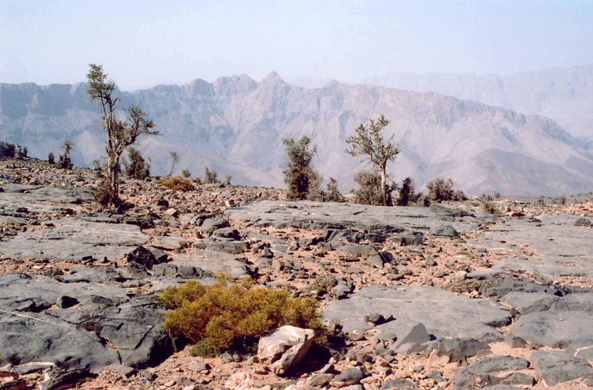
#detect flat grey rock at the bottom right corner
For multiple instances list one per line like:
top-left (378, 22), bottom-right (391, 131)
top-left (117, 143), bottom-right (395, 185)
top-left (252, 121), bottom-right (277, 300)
top-left (530, 351), bottom-right (593, 386)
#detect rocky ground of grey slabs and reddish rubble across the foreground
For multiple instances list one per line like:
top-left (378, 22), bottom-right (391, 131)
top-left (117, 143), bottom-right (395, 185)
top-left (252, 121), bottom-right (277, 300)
top-left (0, 160), bottom-right (593, 390)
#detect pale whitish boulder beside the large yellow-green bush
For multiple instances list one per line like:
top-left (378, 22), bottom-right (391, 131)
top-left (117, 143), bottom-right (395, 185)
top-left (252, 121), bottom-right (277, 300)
top-left (257, 325), bottom-right (315, 375)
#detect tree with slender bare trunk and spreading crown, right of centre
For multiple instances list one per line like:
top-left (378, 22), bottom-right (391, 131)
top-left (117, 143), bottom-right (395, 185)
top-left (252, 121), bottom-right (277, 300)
top-left (346, 115), bottom-right (400, 205)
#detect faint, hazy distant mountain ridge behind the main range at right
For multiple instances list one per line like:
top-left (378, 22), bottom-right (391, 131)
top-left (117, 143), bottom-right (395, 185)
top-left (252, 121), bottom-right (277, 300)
top-left (365, 65), bottom-right (593, 141)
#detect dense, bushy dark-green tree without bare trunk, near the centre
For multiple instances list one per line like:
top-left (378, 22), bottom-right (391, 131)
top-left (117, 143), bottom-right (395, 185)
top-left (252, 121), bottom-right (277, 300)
top-left (282, 136), bottom-right (318, 200)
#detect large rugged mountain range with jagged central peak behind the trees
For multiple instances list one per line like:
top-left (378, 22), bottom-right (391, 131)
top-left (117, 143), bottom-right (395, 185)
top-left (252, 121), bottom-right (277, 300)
top-left (0, 73), bottom-right (593, 195)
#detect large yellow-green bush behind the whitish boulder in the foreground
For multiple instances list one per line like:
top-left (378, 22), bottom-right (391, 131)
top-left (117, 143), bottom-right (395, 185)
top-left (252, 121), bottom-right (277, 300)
top-left (159, 274), bottom-right (321, 353)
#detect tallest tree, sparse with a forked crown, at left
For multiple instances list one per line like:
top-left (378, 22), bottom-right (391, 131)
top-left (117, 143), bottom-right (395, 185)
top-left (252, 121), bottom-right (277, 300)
top-left (87, 64), bottom-right (159, 204)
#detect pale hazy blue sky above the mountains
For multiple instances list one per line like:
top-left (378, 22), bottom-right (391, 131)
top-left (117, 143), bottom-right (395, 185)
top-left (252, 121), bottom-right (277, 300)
top-left (0, 0), bottom-right (593, 89)
